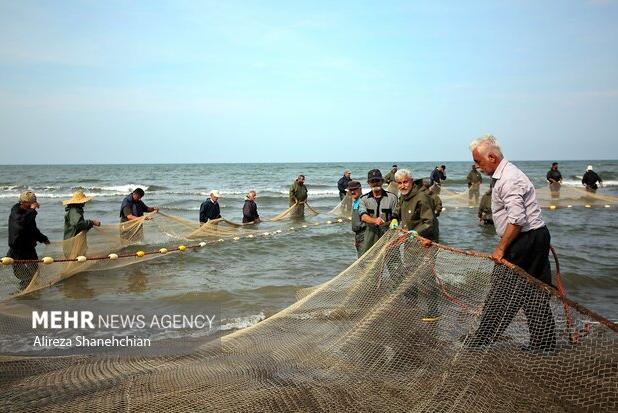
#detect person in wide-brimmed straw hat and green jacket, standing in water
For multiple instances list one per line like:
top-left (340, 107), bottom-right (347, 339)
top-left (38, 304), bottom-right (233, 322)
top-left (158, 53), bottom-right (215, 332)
top-left (62, 190), bottom-right (101, 259)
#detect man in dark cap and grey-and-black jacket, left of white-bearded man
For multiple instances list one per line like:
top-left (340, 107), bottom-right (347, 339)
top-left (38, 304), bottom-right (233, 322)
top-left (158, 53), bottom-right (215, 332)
top-left (358, 169), bottom-right (397, 255)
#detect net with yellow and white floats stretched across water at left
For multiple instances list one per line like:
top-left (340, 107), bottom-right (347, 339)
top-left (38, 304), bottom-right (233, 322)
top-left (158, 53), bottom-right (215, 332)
top-left (0, 204), bottom-right (332, 301)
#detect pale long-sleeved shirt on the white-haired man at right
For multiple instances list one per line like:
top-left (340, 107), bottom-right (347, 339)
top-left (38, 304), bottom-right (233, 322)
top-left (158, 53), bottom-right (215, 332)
top-left (491, 159), bottom-right (545, 237)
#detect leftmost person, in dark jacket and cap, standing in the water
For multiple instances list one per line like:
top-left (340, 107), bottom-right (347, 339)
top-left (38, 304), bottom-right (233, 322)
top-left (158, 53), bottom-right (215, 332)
top-left (6, 191), bottom-right (49, 289)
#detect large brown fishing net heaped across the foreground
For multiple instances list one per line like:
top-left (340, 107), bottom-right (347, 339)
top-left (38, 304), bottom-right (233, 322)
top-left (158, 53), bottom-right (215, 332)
top-left (0, 228), bottom-right (618, 412)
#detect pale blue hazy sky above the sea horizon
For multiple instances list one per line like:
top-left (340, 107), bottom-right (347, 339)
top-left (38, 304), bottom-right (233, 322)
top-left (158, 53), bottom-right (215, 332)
top-left (0, 0), bottom-right (618, 164)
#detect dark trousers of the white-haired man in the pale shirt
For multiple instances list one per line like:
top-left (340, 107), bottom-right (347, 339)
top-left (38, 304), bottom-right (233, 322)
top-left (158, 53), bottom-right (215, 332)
top-left (469, 227), bottom-right (556, 351)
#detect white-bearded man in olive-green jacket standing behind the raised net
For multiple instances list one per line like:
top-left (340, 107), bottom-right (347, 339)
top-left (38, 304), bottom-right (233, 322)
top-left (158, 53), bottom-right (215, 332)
top-left (390, 169), bottom-right (440, 322)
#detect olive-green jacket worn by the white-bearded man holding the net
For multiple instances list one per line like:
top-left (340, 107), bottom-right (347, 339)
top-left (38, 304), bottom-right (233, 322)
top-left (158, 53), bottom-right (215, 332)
top-left (393, 185), bottom-right (440, 242)
